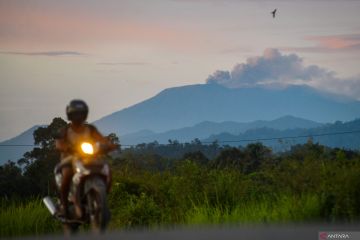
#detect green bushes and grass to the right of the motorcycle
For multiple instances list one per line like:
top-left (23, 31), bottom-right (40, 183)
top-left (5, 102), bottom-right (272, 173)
top-left (105, 141), bottom-right (360, 227)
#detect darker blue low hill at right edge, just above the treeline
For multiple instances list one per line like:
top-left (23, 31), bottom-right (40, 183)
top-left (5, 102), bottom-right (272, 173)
top-left (202, 119), bottom-right (360, 151)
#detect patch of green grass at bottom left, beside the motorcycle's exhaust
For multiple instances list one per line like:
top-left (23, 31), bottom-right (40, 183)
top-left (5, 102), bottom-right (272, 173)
top-left (0, 199), bottom-right (61, 237)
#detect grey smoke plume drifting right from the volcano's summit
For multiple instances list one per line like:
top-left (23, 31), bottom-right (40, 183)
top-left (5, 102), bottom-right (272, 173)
top-left (206, 49), bottom-right (360, 100)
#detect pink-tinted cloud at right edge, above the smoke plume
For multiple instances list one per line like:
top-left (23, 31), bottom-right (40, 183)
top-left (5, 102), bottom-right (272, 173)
top-left (281, 33), bottom-right (360, 53)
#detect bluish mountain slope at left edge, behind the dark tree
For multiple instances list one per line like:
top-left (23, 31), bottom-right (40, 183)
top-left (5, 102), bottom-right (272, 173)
top-left (0, 125), bottom-right (41, 165)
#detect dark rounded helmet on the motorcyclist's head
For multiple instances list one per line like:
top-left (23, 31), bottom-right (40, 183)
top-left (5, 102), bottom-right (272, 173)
top-left (66, 99), bottom-right (89, 124)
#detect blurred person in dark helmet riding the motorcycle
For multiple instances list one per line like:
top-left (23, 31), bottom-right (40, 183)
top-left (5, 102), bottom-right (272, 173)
top-left (55, 99), bottom-right (117, 218)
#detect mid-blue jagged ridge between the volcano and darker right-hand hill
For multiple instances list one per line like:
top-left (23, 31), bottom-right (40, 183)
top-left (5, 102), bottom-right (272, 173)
top-left (120, 116), bottom-right (322, 145)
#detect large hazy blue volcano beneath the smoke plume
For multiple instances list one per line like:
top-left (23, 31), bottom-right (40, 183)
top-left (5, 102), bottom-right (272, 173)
top-left (95, 84), bottom-right (360, 136)
